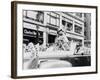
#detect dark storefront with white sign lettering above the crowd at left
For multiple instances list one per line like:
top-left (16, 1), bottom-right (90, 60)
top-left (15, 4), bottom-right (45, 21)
top-left (23, 28), bottom-right (43, 45)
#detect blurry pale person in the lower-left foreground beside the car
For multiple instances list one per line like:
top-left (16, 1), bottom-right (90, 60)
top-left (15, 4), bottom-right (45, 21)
top-left (23, 42), bottom-right (38, 69)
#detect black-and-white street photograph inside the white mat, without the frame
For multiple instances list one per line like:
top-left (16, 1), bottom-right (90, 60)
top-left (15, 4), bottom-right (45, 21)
top-left (22, 10), bottom-right (91, 69)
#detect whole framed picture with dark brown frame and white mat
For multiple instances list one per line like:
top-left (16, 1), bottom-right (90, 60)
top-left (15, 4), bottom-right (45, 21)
top-left (12, 1), bottom-right (97, 78)
